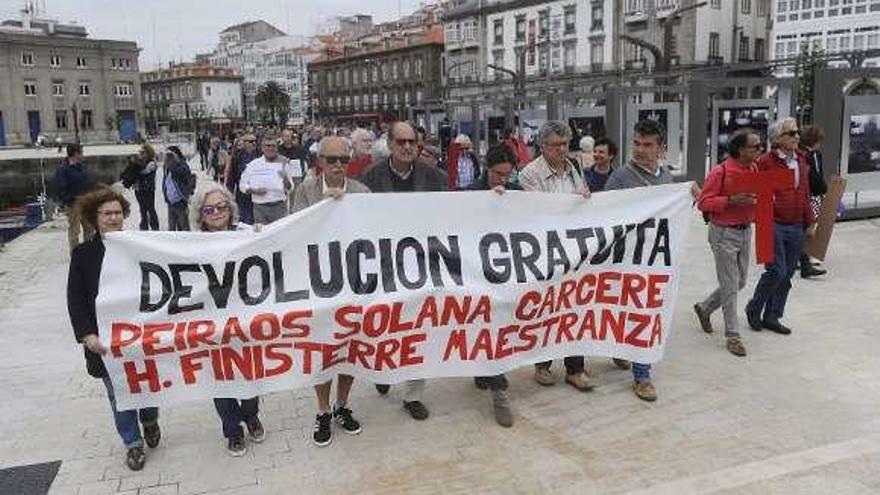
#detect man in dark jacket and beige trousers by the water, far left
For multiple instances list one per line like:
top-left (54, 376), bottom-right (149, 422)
top-left (55, 143), bottom-right (95, 251)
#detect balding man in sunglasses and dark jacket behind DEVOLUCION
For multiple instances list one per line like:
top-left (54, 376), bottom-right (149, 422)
top-left (361, 122), bottom-right (446, 420)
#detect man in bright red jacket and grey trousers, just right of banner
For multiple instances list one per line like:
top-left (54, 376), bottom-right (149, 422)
top-left (694, 129), bottom-right (761, 356)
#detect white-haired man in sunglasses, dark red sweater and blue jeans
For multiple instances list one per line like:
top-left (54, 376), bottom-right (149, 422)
top-left (746, 118), bottom-right (816, 335)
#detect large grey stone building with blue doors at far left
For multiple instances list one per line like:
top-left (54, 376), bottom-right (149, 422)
top-left (0, 12), bottom-right (142, 146)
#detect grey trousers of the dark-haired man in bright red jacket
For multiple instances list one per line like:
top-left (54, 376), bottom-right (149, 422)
top-left (702, 223), bottom-right (752, 338)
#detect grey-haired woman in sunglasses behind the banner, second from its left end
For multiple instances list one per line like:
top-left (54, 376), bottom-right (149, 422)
top-left (190, 182), bottom-right (266, 457)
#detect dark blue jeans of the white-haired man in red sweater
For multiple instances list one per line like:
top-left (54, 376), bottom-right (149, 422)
top-left (747, 223), bottom-right (804, 323)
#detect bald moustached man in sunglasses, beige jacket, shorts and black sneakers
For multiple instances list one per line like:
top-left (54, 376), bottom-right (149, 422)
top-left (293, 136), bottom-right (370, 447)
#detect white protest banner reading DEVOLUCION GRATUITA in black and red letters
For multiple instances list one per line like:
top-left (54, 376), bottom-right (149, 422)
top-left (97, 184), bottom-right (691, 409)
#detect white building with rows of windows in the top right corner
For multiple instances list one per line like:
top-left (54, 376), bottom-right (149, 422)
top-left (773, 0), bottom-right (880, 73)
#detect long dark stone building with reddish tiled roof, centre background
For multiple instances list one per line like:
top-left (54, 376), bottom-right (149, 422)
top-left (309, 25), bottom-right (443, 120)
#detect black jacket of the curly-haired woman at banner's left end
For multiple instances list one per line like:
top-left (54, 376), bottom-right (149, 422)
top-left (67, 236), bottom-right (107, 378)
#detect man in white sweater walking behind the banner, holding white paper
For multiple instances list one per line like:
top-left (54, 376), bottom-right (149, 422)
top-left (238, 136), bottom-right (291, 225)
